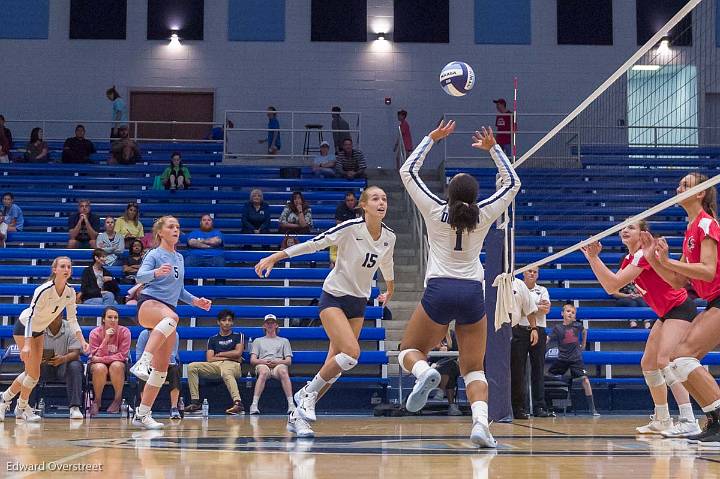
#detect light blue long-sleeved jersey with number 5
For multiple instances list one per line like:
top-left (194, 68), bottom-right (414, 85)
top-left (135, 248), bottom-right (197, 306)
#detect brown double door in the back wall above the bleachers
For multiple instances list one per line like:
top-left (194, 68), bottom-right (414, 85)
top-left (130, 91), bottom-right (215, 140)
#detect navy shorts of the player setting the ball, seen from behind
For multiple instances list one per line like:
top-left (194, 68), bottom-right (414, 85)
top-left (420, 278), bottom-right (485, 324)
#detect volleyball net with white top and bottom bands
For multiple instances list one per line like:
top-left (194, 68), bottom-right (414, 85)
top-left (494, 0), bottom-right (720, 327)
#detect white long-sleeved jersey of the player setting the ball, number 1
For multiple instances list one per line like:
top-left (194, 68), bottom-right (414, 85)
top-left (400, 136), bottom-right (520, 286)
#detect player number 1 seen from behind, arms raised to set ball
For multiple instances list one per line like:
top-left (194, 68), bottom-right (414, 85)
top-left (398, 121), bottom-right (520, 447)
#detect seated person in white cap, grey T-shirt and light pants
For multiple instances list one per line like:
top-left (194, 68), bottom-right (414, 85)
top-left (250, 314), bottom-right (295, 414)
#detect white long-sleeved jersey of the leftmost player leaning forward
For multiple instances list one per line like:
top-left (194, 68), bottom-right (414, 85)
top-left (18, 281), bottom-right (80, 337)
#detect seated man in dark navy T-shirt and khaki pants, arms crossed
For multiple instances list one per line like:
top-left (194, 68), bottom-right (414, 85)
top-left (185, 309), bottom-right (245, 415)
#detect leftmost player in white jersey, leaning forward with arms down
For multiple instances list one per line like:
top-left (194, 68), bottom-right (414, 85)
top-left (0, 256), bottom-right (90, 422)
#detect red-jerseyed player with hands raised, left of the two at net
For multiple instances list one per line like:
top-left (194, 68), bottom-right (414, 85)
top-left (582, 221), bottom-right (700, 437)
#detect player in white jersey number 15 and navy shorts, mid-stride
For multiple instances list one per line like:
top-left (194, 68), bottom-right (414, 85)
top-left (255, 186), bottom-right (396, 437)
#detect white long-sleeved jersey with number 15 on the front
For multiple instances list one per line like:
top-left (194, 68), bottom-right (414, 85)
top-left (285, 218), bottom-right (395, 298)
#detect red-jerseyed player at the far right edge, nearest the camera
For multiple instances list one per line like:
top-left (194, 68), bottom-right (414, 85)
top-left (641, 173), bottom-right (720, 448)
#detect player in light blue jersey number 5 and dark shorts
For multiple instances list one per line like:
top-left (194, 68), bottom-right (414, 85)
top-left (130, 216), bottom-right (212, 429)
